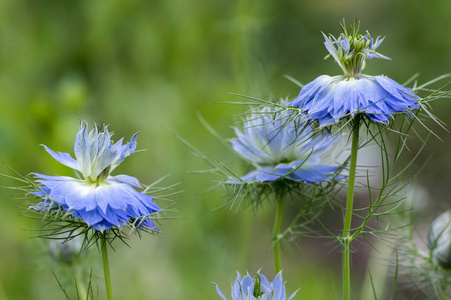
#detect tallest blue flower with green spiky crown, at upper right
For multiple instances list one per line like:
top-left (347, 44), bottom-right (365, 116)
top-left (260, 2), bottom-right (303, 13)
top-left (288, 19), bottom-right (421, 126)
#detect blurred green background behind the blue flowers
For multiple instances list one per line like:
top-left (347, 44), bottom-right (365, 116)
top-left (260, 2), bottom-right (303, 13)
top-left (0, 0), bottom-right (451, 300)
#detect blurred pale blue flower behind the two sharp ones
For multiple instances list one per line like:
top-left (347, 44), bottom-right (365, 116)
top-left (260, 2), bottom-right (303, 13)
top-left (231, 107), bottom-right (341, 184)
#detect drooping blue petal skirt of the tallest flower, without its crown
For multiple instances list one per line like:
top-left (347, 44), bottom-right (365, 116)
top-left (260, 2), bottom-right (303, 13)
top-left (288, 75), bottom-right (420, 126)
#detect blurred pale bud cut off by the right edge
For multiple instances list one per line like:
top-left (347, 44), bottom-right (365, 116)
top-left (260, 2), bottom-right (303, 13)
top-left (428, 211), bottom-right (451, 268)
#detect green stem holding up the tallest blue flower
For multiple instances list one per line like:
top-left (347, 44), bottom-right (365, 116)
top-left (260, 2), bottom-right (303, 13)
top-left (342, 115), bottom-right (360, 300)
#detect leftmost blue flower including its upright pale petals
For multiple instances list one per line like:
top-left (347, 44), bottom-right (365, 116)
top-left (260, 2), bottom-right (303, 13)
top-left (30, 122), bottom-right (161, 232)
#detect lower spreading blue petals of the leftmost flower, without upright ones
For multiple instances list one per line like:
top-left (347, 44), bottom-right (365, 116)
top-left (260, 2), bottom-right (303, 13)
top-left (30, 173), bottom-right (161, 231)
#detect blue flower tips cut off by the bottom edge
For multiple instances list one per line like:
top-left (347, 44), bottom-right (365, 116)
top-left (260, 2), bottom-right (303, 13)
top-left (216, 272), bottom-right (297, 300)
